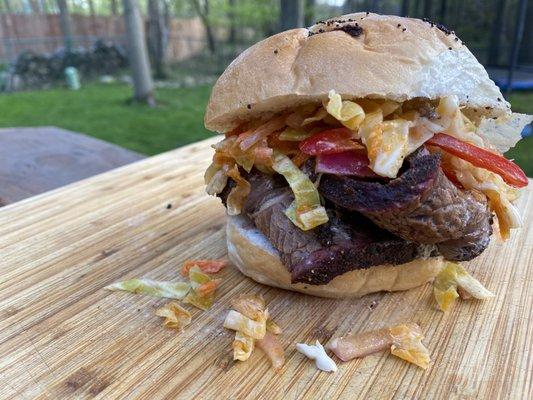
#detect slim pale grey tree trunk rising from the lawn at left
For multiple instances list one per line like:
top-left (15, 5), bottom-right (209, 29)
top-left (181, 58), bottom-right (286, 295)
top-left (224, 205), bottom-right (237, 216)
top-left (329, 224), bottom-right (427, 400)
top-left (123, 0), bottom-right (155, 106)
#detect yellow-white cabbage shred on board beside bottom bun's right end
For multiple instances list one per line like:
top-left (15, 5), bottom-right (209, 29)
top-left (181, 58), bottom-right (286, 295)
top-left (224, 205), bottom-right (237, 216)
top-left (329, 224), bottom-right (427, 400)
top-left (433, 262), bottom-right (494, 311)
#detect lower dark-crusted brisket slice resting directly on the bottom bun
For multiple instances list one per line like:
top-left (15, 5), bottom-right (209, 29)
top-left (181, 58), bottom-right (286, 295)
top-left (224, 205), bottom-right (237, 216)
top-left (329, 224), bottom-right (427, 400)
top-left (220, 171), bottom-right (433, 285)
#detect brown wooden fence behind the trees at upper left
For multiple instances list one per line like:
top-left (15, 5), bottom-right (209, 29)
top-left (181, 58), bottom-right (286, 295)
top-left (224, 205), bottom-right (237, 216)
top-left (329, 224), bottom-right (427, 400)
top-left (0, 14), bottom-right (206, 62)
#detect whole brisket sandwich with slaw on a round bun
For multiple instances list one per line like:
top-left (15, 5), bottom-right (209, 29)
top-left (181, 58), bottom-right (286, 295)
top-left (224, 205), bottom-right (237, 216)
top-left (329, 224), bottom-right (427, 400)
top-left (205, 13), bottom-right (533, 297)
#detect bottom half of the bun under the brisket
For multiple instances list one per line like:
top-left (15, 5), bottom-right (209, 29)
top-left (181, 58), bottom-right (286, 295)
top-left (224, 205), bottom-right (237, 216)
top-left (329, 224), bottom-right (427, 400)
top-left (226, 216), bottom-right (444, 297)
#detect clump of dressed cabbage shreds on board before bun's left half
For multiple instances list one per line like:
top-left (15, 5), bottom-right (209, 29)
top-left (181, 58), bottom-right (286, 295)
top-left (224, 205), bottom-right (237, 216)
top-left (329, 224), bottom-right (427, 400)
top-left (224, 294), bottom-right (285, 370)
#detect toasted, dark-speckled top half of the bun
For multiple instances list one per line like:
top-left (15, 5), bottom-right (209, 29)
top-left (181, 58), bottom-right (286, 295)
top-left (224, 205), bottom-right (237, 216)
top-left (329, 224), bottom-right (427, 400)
top-left (205, 13), bottom-right (509, 132)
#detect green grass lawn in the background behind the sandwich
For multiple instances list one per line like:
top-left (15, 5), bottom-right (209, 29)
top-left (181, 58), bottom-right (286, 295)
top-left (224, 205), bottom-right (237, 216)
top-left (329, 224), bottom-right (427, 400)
top-left (0, 84), bottom-right (533, 177)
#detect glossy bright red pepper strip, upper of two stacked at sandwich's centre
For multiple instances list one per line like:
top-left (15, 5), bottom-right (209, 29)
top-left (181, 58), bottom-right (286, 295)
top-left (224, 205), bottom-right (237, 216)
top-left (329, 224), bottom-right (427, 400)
top-left (300, 128), bottom-right (361, 156)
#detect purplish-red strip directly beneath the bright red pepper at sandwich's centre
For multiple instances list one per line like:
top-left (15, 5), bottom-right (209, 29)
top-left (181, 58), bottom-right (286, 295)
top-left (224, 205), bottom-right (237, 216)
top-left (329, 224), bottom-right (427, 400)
top-left (316, 150), bottom-right (381, 178)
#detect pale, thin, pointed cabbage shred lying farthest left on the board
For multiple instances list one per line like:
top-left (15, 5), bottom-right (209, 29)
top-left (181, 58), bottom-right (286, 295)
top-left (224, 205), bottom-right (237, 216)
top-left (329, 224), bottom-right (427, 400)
top-left (104, 279), bottom-right (191, 299)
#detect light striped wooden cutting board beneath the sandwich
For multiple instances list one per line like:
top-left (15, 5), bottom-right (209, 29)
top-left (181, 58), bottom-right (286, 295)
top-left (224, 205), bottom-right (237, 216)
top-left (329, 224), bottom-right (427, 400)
top-left (0, 138), bottom-right (533, 399)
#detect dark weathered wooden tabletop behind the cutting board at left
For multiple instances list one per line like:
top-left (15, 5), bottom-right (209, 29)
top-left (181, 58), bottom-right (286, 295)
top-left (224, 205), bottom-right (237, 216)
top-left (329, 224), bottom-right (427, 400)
top-left (0, 127), bottom-right (144, 206)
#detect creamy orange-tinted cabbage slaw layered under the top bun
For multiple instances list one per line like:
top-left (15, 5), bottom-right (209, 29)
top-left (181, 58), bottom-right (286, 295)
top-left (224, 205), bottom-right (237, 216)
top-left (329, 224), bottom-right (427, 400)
top-left (205, 90), bottom-right (533, 234)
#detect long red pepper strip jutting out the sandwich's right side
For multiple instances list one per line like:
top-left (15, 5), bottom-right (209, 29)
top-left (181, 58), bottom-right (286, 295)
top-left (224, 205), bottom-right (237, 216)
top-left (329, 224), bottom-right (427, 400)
top-left (426, 133), bottom-right (528, 187)
